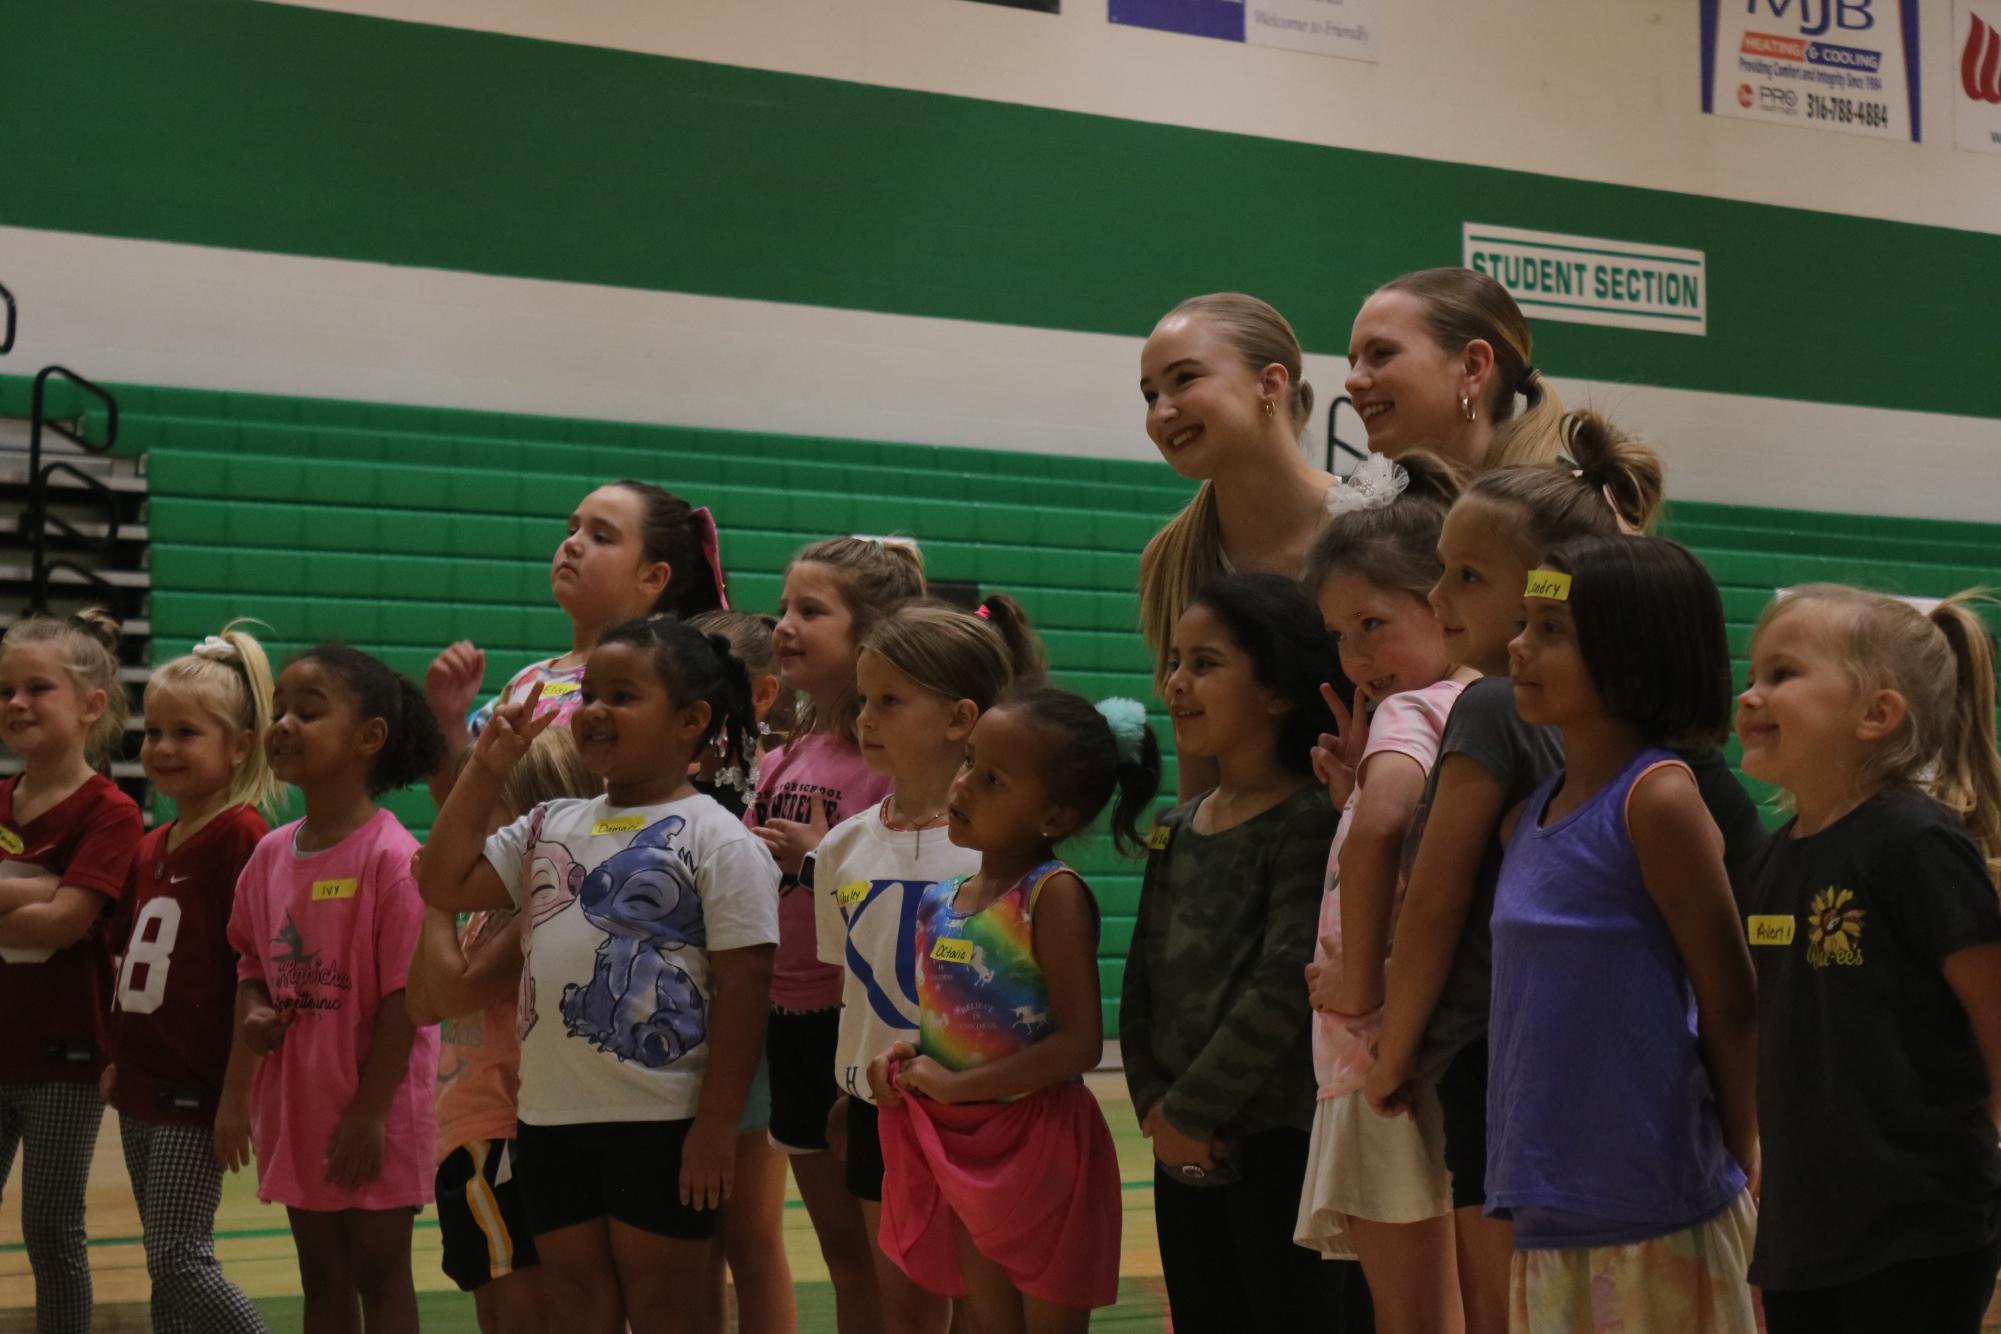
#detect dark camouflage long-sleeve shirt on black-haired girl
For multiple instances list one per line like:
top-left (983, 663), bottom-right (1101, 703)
top-left (1119, 784), bottom-right (1339, 1136)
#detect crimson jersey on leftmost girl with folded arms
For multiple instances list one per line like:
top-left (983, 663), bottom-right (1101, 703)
top-left (0, 774), bottom-right (146, 1082)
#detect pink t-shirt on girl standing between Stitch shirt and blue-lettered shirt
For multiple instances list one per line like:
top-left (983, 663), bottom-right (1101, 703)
top-left (744, 734), bottom-right (890, 1010)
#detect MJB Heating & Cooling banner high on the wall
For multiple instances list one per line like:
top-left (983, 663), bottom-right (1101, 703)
top-left (1703, 0), bottom-right (1921, 144)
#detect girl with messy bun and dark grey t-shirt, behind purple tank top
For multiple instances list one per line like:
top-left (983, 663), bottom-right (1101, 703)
top-left (1363, 414), bottom-right (1661, 1334)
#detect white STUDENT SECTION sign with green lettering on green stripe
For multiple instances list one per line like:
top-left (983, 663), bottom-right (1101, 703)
top-left (1461, 222), bottom-right (1709, 336)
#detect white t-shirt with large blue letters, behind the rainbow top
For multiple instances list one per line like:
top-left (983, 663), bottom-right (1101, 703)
top-left (812, 802), bottom-right (980, 1102)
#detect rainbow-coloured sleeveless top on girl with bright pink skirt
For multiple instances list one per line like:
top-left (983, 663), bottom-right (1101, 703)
top-left (916, 860), bottom-right (1069, 1070)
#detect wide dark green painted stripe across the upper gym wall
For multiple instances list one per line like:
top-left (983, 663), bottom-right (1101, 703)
top-left (0, 0), bottom-right (2001, 418)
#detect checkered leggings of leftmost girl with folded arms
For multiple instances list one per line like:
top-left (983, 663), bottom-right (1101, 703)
top-left (0, 1080), bottom-right (104, 1334)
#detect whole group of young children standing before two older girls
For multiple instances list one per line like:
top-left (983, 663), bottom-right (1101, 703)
top-left (0, 428), bottom-right (2001, 1334)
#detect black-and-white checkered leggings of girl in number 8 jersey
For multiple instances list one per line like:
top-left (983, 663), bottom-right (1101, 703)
top-left (118, 1114), bottom-right (264, 1334)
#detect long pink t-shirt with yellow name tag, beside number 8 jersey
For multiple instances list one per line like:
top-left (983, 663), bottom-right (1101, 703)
top-left (230, 810), bottom-right (438, 1210)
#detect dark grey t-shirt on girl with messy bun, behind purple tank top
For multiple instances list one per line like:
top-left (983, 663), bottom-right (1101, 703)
top-left (1411, 676), bottom-right (1563, 1080)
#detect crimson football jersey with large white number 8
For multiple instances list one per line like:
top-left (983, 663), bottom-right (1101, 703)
top-left (112, 806), bottom-right (266, 1126)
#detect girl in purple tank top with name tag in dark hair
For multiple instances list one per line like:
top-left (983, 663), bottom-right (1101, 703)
top-left (1487, 536), bottom-right (1752, 1334)
